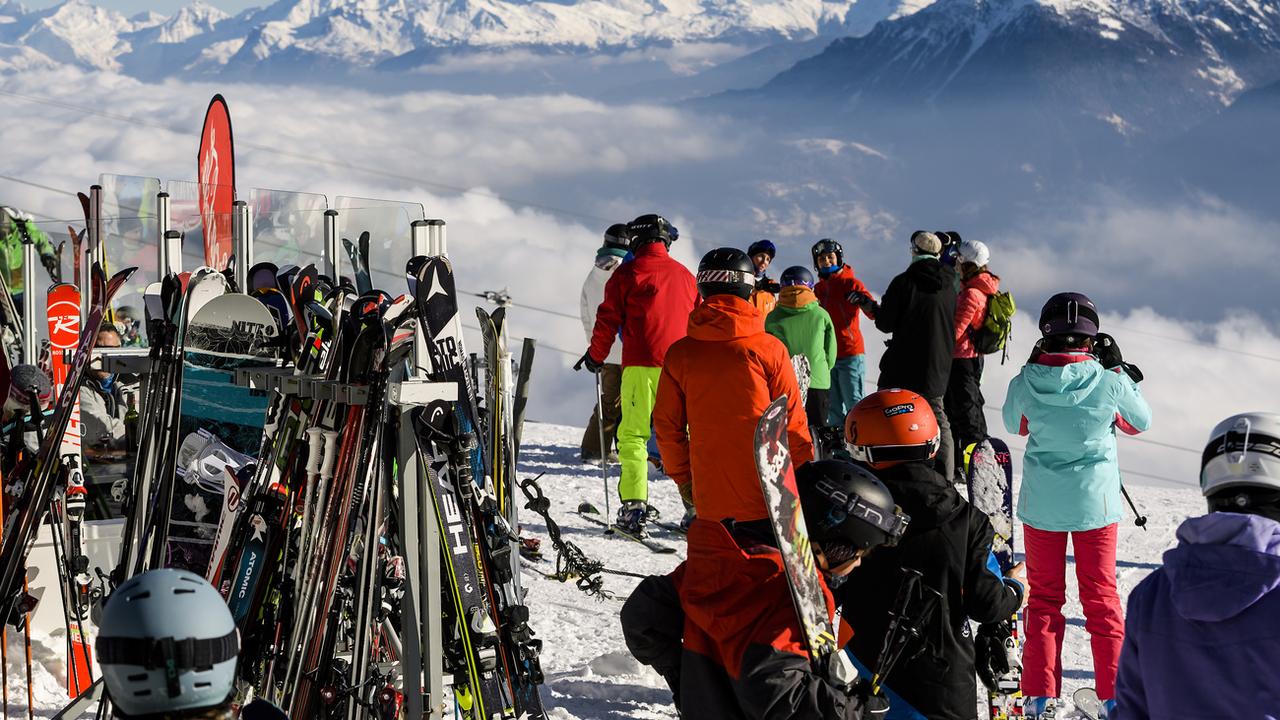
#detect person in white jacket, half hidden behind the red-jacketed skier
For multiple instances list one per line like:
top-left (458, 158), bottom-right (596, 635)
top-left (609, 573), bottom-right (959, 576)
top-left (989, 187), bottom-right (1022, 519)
top-left (581, 224), bottom-right (631, 462)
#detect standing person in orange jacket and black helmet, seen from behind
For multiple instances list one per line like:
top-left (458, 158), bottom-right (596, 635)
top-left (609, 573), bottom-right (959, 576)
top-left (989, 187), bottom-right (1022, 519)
top-left (653, 247), bottom-right (813, 532)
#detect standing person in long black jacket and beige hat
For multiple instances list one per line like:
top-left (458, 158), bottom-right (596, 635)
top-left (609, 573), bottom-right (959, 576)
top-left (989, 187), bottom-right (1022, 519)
top-left (868, 232), bottom-right (960, 480)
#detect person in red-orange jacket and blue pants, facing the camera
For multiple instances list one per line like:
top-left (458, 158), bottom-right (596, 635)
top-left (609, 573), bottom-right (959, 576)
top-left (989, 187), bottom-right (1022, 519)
top-left (812, 238), bottom-right (876, 428)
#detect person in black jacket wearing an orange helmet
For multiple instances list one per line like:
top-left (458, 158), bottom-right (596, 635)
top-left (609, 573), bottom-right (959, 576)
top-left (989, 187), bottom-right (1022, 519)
top-left (836, 389), bottom-right (1024, 720)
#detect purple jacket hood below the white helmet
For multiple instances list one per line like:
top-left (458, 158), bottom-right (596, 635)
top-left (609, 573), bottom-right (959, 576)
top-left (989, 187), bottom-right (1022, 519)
top-left (1165, 512), bottom-right (1280, 623)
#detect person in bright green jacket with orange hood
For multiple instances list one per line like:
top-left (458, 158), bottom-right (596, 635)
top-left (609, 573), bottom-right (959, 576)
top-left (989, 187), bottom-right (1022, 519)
top-left (764, 265), bottom-right (836, 428)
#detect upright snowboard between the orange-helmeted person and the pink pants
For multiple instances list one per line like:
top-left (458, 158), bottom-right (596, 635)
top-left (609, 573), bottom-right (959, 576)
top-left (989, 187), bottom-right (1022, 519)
top-left (966, 437), bottom-right (1023, 720)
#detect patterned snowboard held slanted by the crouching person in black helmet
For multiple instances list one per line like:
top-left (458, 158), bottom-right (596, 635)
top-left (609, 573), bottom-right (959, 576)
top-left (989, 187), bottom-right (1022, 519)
top-left (755, 395), bottom-right (844, 676)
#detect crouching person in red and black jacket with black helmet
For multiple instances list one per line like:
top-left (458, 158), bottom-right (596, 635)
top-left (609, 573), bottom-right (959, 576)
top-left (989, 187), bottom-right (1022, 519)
top-left (622, 460), bottom-right (908, 720)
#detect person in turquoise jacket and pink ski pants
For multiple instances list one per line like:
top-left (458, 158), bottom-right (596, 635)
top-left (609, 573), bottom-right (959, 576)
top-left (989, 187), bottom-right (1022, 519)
top-left (1004, 292), bottom-right (1151, 717)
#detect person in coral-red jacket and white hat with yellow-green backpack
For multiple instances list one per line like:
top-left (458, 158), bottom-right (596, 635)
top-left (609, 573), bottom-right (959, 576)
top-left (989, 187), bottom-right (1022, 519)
top-left (942, 240), bottom-right (1000, 470)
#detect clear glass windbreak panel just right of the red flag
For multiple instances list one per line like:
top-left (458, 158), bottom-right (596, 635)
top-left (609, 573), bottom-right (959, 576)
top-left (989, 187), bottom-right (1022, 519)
top-left (248, 188), bottom-right (329, 272)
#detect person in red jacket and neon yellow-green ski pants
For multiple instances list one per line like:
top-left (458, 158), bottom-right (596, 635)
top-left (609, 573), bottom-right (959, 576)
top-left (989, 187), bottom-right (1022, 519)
top-left (575, 215), bottom-right (698, 534)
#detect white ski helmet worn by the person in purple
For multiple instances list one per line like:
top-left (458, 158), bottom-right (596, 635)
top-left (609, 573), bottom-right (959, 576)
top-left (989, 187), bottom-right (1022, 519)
top-left (1201, 413), bottom-right (1280, 497)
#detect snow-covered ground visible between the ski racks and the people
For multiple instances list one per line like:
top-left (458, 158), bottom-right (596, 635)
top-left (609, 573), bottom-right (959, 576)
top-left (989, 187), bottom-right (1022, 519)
top-left (8, 424), bottom-right (1203, 720)
